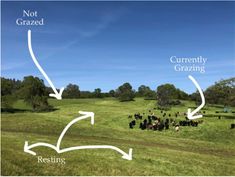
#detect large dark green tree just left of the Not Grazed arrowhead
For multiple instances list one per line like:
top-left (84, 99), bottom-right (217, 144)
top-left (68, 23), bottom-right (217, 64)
top-left (20, 76), bottom-right (51, 111)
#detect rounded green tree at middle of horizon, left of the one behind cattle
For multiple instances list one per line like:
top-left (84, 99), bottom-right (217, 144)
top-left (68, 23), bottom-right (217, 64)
top-left (116, 83), bottom-right (135, 101)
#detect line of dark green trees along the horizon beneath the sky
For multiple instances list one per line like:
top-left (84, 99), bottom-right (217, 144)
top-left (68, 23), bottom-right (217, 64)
top-left (1, 76), bottom-right (235, 111)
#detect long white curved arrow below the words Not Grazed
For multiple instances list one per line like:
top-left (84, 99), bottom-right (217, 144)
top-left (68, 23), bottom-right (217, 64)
top-left (28, 30), bottom-right (64, 100)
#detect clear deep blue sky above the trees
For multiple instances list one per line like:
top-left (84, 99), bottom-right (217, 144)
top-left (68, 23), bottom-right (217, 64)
top-left (1, 2), bottom-right (235, 93)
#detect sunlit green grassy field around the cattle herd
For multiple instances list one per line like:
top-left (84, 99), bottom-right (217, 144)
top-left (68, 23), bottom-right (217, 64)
top-left (1, 98), bottom-right (235, 176)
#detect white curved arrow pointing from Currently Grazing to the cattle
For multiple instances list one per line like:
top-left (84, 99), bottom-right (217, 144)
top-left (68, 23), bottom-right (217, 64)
top-left (187, 75), bottom-right (205, 119)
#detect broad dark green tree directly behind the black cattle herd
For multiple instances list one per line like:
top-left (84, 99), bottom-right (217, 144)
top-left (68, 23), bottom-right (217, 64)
top-left (157, 84), bottom-right (176, 108)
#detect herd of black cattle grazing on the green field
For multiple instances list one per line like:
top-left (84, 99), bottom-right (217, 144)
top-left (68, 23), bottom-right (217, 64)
top-left (128, 110), bottom-right (235, 131)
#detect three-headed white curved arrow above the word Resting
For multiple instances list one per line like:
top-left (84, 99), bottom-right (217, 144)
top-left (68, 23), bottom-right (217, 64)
top-left (24, 111), bottom-right (132, 160)
